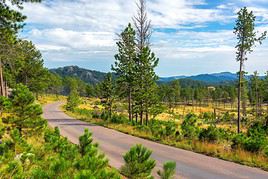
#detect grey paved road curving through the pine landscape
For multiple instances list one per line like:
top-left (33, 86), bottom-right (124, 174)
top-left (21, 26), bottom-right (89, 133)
top-left (44, 102), bottom-right (268, 179)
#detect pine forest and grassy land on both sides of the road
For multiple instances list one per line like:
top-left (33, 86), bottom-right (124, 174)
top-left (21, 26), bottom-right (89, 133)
top-left (0, 0), bottom-right (268, 179)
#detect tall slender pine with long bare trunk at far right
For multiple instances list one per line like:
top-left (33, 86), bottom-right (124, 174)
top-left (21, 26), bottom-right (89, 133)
top-left (234, 7), bottom-right (266, 133)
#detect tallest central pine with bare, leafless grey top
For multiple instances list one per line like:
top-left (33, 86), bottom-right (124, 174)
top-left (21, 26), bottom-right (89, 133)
top-left (133, 0), bottom-right (159, 124)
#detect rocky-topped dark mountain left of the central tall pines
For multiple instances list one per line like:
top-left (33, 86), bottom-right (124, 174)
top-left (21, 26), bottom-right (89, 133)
top-left (50, 66), bottom-right (106, 84)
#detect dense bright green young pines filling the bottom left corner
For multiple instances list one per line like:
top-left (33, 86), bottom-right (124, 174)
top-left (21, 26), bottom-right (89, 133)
top-left (0, 128), bottom-right (120, 179)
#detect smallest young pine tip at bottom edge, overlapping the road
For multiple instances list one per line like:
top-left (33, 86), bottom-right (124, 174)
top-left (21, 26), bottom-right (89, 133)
top-left (157, 161), bottom-right (176, 179)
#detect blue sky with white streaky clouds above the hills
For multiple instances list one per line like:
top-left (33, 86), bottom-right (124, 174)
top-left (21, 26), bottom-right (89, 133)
top-left (21, 0), bottom-right (268, 76)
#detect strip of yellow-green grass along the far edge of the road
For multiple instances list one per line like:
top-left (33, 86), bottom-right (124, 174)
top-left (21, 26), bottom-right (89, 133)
top-left (65, 105), bottom-right (268, 171)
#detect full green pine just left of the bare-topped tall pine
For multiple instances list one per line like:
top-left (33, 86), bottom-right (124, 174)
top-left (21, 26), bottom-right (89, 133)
top-left (112, 24), bottom-right (136, 121)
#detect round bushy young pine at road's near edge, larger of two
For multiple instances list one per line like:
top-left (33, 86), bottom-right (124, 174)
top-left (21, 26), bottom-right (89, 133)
top-left (121, 145), bottom-right (155, 179)
